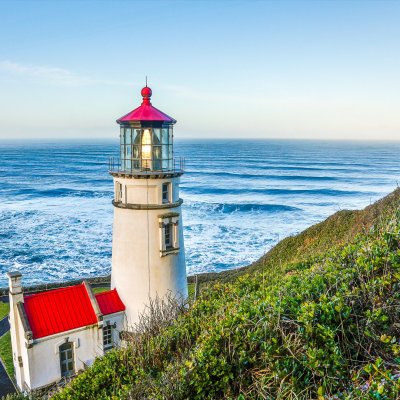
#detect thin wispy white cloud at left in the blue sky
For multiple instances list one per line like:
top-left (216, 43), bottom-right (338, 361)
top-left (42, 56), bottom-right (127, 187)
top-left (0, 60), bottom-right (126, 85)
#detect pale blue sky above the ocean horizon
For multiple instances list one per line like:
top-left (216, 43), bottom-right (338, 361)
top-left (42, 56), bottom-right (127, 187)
top-left (0, 0), bottom-right (400, 140)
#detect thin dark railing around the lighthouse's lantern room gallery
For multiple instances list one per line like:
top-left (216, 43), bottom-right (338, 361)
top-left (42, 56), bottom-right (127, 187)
top-left (108, 157), bottom-right (185, 174)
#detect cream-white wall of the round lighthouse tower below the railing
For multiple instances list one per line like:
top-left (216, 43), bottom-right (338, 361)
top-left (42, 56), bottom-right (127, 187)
top-left (111, 177), bottom-right (187, 327)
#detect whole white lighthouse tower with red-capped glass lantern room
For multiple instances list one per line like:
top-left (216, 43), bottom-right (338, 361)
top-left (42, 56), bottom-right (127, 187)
top-left (110, 85), bottom-right (187, 330)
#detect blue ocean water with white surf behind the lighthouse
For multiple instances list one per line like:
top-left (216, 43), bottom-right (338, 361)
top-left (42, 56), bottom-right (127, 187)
top-left (0, 140), bottom-right (400, 286)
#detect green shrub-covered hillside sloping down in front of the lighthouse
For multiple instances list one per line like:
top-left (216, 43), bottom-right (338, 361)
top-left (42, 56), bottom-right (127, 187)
top-left (50, 190), bottom-right (400, 400)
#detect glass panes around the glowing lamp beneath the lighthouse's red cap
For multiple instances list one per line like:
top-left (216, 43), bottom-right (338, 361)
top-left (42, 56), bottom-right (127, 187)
top-left (121, 127), bottom-right (173, 172)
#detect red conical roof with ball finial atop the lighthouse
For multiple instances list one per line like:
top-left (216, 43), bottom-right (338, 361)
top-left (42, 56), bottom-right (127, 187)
top-left (117, 86), bottom-right (176, 124)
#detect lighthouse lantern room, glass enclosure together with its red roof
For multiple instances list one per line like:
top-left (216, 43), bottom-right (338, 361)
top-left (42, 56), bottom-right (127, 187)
top-left (117, 85), bottom-right (176, 173)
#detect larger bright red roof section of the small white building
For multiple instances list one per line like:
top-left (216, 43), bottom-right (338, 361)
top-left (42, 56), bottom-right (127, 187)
top-left (24, 283), bottom-right (97, 339)
